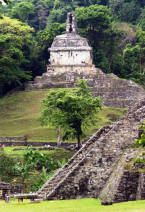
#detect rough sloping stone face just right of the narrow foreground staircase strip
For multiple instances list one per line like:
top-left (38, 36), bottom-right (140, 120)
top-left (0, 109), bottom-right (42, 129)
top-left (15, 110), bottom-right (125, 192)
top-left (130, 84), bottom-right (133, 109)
top-left (48, 100), bottom-right (145, 199)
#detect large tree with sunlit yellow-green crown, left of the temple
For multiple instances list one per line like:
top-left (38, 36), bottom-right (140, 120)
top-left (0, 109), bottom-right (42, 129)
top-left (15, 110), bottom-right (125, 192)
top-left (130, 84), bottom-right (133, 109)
top-left (0, 17), bottom-right (33, 94)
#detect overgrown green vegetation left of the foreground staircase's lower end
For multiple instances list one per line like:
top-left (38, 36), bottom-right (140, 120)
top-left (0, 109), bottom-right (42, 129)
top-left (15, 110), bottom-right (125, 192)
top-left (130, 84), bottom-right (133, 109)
top-left (0, 149), bottom-right (71, 192)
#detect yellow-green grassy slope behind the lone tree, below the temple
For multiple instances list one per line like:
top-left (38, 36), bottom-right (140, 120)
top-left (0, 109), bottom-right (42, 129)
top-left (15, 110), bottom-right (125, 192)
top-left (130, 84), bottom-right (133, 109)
top-left (0, 90), bottom-right (125, 141)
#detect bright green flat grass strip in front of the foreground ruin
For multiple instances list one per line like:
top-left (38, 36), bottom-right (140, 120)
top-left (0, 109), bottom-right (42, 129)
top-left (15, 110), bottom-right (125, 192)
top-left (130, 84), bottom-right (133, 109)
top-left (0, 199), bottom-right (145, 212)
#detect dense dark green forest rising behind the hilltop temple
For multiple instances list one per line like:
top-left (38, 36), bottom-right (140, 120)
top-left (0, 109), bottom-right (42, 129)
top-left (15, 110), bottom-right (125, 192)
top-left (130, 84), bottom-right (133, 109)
top-left (0, 0), bottom-right (145, 95)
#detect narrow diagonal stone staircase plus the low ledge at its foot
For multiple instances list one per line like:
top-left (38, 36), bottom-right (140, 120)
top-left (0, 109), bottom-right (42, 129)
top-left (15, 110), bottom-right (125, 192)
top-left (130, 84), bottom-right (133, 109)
top-left (6, 126), bottom-right (111, 202)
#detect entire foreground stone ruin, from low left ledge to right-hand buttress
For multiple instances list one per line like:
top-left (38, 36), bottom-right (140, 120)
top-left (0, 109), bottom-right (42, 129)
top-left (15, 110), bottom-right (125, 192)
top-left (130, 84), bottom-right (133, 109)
top-left (7, 99), bottom-right (145, 204)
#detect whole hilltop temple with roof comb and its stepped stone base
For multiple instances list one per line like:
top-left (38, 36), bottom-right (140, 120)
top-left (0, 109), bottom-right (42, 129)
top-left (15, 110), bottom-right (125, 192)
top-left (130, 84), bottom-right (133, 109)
top-left (26, 13), bottom-right (145, 107)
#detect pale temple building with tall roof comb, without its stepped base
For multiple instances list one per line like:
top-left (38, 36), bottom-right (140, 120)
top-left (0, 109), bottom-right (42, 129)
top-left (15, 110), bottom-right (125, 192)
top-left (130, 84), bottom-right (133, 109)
top-left (48, 13), bottom-right (92, 71)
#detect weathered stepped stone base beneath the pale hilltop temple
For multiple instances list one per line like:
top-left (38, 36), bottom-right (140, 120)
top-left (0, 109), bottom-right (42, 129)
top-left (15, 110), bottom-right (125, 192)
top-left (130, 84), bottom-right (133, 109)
top-left (26, 65), bottom-right (145, 107)
